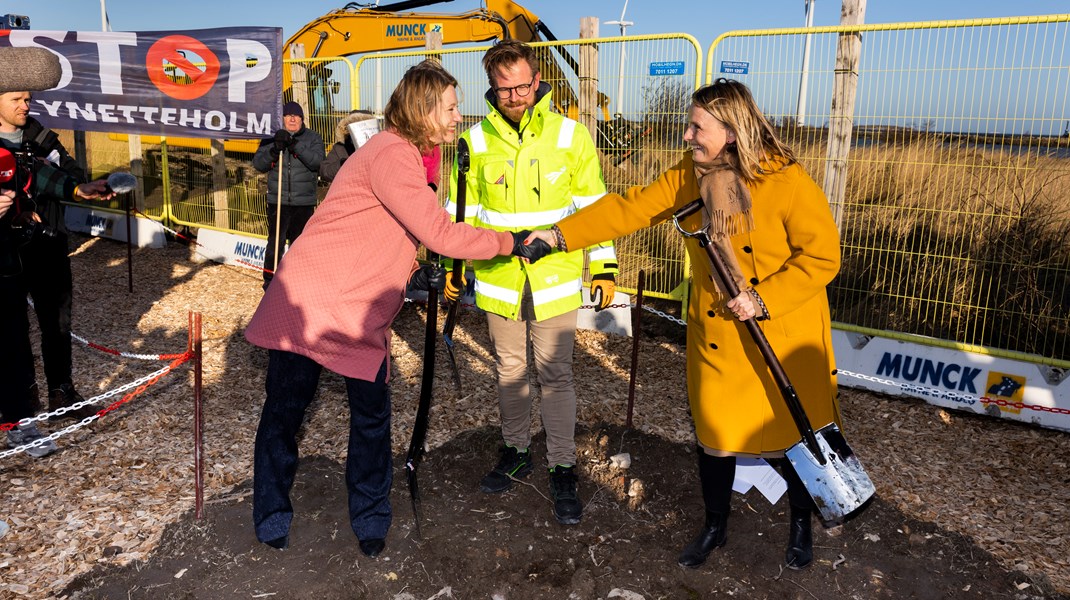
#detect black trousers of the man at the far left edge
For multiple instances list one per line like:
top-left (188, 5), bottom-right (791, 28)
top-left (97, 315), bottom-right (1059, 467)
top-left (22, 233), bottom-right (74, 390)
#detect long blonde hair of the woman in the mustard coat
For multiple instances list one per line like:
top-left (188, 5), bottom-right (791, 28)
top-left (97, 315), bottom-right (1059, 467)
top-left (691, 78), bottom-right (795, 183)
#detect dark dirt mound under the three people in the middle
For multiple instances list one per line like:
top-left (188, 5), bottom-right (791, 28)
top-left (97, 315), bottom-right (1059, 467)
top-left (65, 426), bottom-right (1055, 600)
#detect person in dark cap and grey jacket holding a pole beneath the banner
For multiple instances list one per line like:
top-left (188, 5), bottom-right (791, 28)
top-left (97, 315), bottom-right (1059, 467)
top-left (253, 102), bottom-right (323, 290)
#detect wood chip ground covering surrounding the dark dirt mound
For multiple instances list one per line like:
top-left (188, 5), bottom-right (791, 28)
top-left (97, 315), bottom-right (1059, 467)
top-left (0, 235), bottom-right (1070, 598)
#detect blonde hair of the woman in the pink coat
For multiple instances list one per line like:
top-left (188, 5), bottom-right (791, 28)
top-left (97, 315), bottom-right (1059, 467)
top-left (383, 60), bottom-right (457, 153)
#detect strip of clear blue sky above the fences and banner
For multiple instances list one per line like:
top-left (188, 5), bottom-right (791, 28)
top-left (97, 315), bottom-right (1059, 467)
top-left (10, 0), bottom-right (1070, 43)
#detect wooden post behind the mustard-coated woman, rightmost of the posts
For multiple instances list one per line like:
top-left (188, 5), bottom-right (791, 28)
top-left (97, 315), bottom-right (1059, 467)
top-left (825, 0), bottom-right (866, 227)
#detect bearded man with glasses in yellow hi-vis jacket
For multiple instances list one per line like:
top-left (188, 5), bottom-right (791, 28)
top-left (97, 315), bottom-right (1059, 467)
top-left (447, 41), bottom-right (617, 524)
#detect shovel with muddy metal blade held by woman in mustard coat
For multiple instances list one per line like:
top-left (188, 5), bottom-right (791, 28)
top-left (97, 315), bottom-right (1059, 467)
top-left (673, 199), bottom-right (876, 527)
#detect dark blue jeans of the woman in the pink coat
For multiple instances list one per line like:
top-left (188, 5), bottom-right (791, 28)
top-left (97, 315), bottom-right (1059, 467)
top-left (253, 350), bottom-right (394, 541)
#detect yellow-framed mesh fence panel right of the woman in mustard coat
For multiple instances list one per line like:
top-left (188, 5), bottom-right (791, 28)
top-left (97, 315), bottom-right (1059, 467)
top-left (706, 15), bottom-right (1070, 366)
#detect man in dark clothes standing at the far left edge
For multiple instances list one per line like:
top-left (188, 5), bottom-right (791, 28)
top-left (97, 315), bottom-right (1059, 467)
top-left (0, 91), bottom-right (100, 444)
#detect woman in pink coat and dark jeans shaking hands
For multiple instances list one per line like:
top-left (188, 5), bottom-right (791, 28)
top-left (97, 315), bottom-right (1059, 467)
top-left (245, 61), bottom-right (549, 556)
